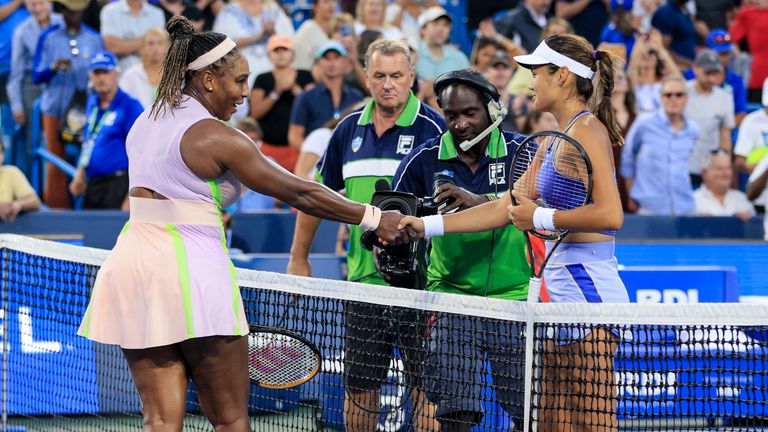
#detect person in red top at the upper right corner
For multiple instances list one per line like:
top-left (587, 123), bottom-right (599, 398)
top-left (728, 0), bottom-right (768, 103)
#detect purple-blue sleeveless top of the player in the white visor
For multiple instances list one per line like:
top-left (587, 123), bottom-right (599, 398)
top-left (536, 110), bottom-right (616, 236)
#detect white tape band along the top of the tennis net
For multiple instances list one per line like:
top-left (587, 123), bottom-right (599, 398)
top-left (0, 234), bottom-right (768, 326)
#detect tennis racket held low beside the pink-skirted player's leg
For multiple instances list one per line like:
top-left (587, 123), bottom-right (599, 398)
top-left (248, 296), bottom-right (323, 389)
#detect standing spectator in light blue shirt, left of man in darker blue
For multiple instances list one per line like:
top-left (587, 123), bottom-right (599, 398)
top-left (6, 0), bottom-right (64, 170)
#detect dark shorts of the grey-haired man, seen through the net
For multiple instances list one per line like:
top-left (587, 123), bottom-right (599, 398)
top-left (344, 302), bottom-right (428, 393)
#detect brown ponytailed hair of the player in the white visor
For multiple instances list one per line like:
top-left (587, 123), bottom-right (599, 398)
top-left (547, 34), bottom-right (624, 145)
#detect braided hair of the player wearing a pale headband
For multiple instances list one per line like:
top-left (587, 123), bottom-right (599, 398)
top-left (150, 16), bottom-right (240, 118)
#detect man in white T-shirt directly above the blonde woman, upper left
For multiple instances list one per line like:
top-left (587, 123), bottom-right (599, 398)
top-left (99, 0), bottom-right (165, 71)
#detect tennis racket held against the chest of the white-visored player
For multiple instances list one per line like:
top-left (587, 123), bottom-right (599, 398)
top-left (510, 131), bottom-right (592, 301)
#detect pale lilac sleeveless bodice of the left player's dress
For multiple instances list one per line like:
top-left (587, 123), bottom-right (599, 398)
top-left (126, 95), bottom-right (244, 208)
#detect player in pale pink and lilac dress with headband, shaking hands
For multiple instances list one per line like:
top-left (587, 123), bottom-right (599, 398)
top-left (79, 17), bottom-right (402, 431)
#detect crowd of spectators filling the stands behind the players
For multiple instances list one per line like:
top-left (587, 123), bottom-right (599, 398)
top-left (0, 0), bottom-right (768, 235)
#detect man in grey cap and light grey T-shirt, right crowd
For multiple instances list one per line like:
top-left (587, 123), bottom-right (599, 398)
top-left (685, 49), bottom-right (736, 185)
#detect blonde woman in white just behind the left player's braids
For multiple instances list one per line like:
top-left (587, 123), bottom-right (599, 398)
top-left (120, 28), bottom-right (171, 108)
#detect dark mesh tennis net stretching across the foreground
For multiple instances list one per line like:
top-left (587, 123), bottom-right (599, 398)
top-left (0, 235), bottom-right (768, 431)
